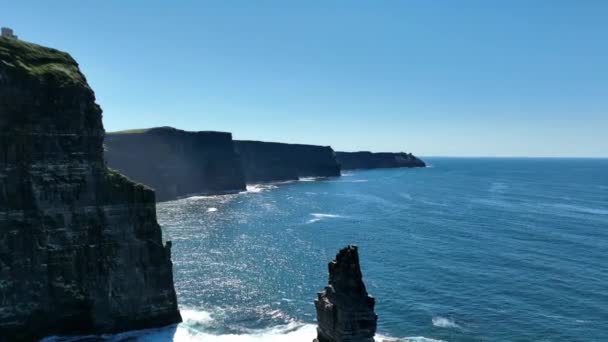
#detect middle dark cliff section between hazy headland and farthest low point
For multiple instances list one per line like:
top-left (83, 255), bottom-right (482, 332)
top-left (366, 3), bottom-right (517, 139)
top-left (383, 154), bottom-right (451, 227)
top-left (235, 140), bottom-right (340, 183)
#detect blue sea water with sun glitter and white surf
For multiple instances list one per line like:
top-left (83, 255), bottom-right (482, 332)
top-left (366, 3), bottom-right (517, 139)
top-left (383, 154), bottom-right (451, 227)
top-left (44, 158), bottom-right (608, 342)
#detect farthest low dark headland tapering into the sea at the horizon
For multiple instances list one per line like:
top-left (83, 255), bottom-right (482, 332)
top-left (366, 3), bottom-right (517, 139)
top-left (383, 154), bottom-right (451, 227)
top-left (336, 151), bottom-right (426, 170)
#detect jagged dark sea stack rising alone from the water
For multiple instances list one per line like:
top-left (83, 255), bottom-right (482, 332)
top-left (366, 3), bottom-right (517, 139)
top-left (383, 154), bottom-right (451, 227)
top-left (314, 246), bottom-right (378, 342)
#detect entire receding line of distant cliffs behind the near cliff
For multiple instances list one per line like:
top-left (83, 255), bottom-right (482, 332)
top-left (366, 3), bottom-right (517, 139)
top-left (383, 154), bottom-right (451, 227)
top-left (104, 126), bottom-right (425, 201)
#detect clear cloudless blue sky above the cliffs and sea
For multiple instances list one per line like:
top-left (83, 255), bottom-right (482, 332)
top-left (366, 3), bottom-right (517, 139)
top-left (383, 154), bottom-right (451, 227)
top-left (0, 0), bottom-right (608, 157)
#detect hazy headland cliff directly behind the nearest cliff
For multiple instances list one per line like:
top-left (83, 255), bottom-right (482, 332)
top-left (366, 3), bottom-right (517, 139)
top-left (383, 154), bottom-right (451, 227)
top-left (105, 127), bottom-right (245, 201)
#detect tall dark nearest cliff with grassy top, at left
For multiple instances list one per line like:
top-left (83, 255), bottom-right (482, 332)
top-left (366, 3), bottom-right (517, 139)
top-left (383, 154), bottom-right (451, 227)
top-left (0, 38), bottom-right (181, 341)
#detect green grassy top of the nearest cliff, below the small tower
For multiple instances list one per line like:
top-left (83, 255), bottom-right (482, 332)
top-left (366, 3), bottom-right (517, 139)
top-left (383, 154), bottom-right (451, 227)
top-left (0, 37), bottom-right (86, 85)
